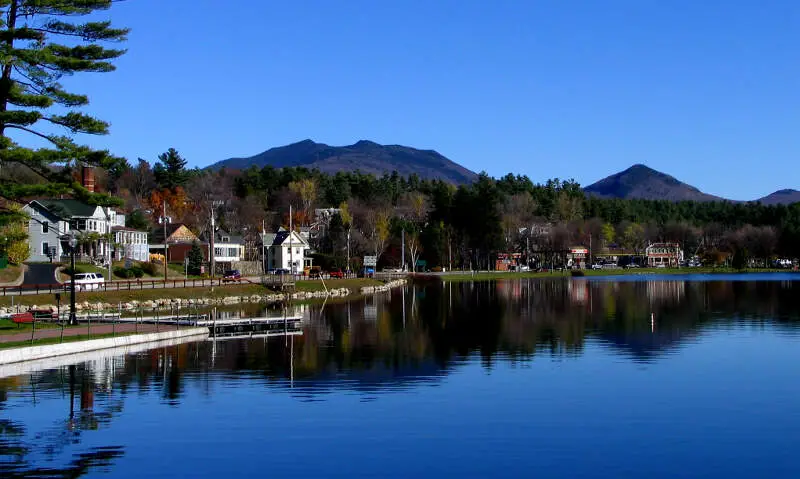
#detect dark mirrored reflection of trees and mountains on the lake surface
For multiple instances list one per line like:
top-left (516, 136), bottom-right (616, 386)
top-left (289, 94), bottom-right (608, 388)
top-left (0, 279), bottom-right (800, 477)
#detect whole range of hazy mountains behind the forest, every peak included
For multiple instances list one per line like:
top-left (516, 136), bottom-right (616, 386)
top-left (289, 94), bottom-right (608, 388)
top-left (209, 140), bottom-right (800, 205)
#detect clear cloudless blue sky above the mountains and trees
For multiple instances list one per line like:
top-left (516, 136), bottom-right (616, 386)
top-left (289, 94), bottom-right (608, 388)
top-left (53, 0), bottom-right (800, 199)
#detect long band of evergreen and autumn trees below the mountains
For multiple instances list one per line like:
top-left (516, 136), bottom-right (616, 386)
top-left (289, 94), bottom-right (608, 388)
top-left (98, 155), bottom-right (800, 268)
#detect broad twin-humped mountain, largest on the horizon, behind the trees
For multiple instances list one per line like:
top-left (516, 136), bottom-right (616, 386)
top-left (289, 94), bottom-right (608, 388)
top-left (209, 139), bottom-right (478, 184)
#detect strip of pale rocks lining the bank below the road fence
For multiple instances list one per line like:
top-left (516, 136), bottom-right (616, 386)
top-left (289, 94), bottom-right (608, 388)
top-left (0, 279), bottom-right (406, 317)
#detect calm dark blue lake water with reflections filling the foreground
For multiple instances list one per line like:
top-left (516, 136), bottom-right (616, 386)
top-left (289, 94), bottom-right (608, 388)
top-left (0, 276), bottom-right (800, 478)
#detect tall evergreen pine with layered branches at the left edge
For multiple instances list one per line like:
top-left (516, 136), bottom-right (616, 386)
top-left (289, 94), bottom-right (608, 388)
top-left (0, 0), bottom-right (128, 224)
